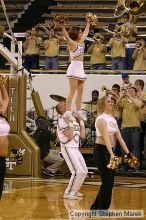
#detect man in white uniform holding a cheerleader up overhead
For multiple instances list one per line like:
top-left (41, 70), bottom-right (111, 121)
top-left (56, 101), bottom-right (88, 199)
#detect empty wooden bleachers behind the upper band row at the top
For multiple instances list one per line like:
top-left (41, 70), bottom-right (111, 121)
top-left (0, 0), bottom-right (146, 70)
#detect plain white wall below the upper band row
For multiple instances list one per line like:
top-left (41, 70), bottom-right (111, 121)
top-left (27, 74), bottom-right (146, 117)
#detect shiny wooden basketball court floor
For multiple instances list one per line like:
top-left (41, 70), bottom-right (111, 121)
top-left (0, 176), bottom-right (146, 220)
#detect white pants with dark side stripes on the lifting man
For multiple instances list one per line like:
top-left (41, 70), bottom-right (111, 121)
top-left (61, 147), bottom-right (88, 194)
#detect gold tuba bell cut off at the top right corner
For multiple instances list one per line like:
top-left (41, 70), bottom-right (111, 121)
top-left (125, 0), bottom-right (146, 15)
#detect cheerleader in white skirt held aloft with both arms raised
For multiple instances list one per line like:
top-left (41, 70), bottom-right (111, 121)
top-left (58, 20), bottom-right (90, 121)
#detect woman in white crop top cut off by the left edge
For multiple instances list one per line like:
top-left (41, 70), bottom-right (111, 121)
top-left (0, 80), bottom-right (10, 199)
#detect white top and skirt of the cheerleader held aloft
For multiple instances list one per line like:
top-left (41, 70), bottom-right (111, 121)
top-left (66, 43), bottom-right (87, 81)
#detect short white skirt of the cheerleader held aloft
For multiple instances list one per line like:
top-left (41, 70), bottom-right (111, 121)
top-left (66, 60), bottom-right (87, 81)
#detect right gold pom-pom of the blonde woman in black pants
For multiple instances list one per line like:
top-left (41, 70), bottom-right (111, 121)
top-left (124, 153), bottom-right (140, 168)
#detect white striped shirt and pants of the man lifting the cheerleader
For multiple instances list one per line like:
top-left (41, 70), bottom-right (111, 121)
top-left (57, 117), bottom-right (88, 194)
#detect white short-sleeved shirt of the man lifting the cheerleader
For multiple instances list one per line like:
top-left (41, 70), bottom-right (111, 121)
top-left (57, 117), bottom-right (80, 148)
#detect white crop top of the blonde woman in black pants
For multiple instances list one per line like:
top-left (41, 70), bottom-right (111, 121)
top-left (95, 113), bottom-right (118, 137)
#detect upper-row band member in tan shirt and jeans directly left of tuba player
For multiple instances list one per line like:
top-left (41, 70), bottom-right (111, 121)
top-left (108, 26), bottom-right (127, 70)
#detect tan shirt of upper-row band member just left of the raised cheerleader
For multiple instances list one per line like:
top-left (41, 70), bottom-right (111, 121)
top-left (44, 37), bottom-right (59, 57)
